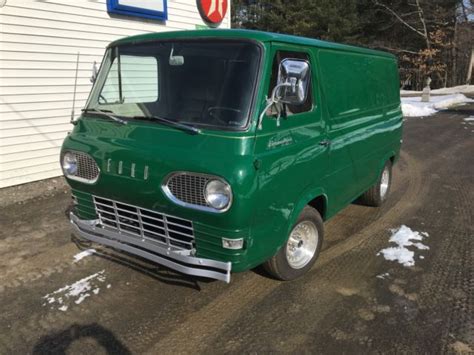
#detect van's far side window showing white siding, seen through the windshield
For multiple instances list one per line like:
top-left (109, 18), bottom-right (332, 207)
top-left (99, 55), bottom-right (158, 104)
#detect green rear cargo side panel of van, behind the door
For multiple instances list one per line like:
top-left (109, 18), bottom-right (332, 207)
top-left (318, 49), bottom-right (402, 215)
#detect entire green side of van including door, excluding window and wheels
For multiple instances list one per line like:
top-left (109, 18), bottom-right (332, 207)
top-left (248, 43), bottom-right (402, 265)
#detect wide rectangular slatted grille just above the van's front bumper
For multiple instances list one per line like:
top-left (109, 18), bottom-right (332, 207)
top-left (94, 196), bottom-right (194, 250)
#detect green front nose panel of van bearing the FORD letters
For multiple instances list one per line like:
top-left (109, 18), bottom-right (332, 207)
top-left (62, 117), bottom-right (255, 218)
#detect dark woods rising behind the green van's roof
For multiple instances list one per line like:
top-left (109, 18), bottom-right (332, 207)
top-left (232, 0), bottom-right (474, 89)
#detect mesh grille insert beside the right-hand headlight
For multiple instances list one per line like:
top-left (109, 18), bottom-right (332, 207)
top-left (166, 173), bottom-right (211, 207)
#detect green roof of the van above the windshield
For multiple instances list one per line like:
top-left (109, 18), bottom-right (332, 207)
top-left (109, 29), bottom-right (395, 59)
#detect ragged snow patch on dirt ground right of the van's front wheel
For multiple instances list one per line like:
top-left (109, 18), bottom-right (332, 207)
top-left (377, 225), bottom-right (429, 266)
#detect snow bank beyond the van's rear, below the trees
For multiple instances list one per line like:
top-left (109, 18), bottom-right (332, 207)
top-left (402, 94), bottom-right (474, 117)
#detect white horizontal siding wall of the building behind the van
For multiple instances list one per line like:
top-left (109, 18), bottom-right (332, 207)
top-left (0, 0), bottom-right (230, 188)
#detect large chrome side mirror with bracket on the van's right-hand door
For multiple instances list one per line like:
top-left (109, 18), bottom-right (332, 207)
top-left (258, 58), bottom-right (311, 129)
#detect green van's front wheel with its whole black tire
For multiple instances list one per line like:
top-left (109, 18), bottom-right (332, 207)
top-left (263, 206), bottom-right (324, 281)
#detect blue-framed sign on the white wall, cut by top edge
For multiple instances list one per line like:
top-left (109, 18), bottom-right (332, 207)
top-left (107, 0), bottom-right (168, 21)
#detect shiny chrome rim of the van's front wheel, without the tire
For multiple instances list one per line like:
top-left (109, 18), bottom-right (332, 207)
top-left (286, 221), bottom-right (319, 269)
